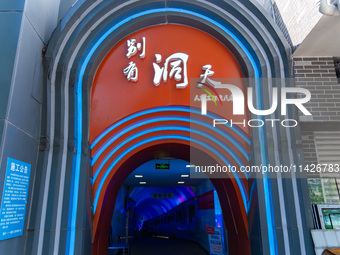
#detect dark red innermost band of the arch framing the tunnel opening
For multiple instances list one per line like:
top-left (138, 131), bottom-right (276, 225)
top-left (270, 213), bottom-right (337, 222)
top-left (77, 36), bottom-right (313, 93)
top-left (93, 142), bottom-right (250, 254)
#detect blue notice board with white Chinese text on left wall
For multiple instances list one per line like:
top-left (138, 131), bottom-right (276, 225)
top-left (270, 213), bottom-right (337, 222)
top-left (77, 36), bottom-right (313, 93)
top-left (0, 158), bottom-right (31, 240)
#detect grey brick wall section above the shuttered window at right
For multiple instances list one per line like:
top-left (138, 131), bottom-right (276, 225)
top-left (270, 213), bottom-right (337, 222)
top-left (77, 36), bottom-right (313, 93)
top-left (294, 57), bottom-right (340, 121)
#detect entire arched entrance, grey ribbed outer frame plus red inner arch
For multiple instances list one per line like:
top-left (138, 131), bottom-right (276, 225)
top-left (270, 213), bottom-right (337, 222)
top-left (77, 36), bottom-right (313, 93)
top-left (37, 0), bottom-right (309, 254)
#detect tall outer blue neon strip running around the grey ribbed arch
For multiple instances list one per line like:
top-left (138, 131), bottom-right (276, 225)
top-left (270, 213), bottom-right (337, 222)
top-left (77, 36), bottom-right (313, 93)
top-left (69, 5), bottom-right (278, 255)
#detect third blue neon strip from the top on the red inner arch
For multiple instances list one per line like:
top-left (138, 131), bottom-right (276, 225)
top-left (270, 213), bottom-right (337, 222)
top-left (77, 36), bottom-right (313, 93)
top-left (92, 125), bottom-right (247, 184)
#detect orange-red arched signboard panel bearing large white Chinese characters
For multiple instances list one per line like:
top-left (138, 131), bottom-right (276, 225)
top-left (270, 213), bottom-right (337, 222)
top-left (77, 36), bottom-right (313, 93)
top-left (90, 25), bottom-right (250, 142)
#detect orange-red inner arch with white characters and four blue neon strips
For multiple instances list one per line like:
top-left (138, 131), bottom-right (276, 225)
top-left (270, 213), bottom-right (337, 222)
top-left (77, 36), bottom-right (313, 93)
top-left (89, 24), bottom-right (251, 255)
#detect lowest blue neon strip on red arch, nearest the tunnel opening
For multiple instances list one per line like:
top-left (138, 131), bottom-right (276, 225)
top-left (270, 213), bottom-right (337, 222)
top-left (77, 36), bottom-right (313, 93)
top-left (93, 135), bottom-right (248, 213)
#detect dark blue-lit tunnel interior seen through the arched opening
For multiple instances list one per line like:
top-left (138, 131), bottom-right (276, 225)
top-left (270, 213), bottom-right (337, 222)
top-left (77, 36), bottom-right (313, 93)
top-left (109, 158), bottom-right (228, 254)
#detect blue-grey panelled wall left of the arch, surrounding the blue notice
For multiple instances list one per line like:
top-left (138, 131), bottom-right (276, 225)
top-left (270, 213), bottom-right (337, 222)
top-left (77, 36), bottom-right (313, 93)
top-left (0, 0), bottom-right (70, 255)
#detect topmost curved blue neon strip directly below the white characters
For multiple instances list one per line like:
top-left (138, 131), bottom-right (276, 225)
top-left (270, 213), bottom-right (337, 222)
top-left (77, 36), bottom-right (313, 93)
top-left (90, 106), bottom-right (251, 149)
